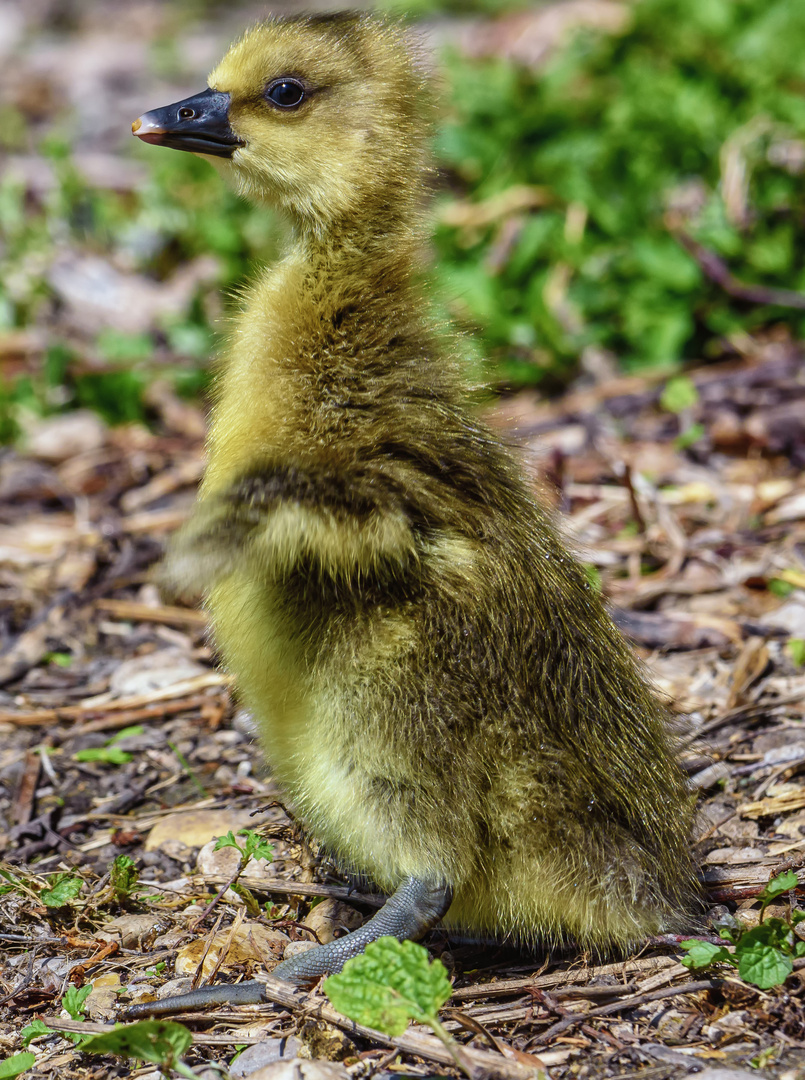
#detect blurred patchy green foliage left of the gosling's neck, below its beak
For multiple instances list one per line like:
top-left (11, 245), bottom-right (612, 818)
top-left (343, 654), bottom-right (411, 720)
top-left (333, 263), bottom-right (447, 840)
top-left (0, 140), bottom-right (279, 442)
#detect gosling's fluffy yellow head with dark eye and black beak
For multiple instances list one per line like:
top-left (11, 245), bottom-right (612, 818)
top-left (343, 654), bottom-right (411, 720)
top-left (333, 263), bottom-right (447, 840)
top-left (132, 14), bottom-right (428, 231)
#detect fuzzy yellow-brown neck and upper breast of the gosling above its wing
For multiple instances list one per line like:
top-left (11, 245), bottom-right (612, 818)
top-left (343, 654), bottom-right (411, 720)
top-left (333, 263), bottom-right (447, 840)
top-left (204, 200), bottom-right (441, 492)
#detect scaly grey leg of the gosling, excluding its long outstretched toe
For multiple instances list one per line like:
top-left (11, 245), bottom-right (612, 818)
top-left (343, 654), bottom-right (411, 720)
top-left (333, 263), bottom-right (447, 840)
top-left (271, 877), bottom-right (453, 986)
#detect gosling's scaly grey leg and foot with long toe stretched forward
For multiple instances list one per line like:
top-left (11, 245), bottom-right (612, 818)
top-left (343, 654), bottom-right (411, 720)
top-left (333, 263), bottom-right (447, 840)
top-left (123, 877), bottom-right (453, 1020)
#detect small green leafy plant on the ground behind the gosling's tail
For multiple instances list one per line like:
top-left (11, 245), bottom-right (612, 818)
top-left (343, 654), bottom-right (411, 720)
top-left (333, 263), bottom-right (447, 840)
top-left (682, 870), bottom-right (805, 990)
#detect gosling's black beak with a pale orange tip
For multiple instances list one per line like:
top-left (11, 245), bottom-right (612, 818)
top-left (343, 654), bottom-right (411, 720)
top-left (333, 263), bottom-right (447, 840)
top-left (132, 90), bottom-right (245, 158)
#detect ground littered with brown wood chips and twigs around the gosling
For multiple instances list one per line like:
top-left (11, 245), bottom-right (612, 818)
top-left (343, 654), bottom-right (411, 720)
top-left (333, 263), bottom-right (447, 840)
top-left (0, 340), bottom-right (805, 1077)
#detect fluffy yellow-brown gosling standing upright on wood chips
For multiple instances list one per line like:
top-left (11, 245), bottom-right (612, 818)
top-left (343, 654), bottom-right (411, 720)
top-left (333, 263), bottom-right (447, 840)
top-left (133, 14), bottom-right (695, 998)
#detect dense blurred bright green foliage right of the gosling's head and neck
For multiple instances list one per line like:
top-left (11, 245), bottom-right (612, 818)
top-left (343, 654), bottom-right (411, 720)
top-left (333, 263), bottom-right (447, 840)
top-left (438, 0), bottom-right (805, 382)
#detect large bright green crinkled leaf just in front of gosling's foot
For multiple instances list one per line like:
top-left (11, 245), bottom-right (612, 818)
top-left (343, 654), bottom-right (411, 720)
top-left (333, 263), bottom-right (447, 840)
top-left (323, 937), bottom-right (452, 1036)
